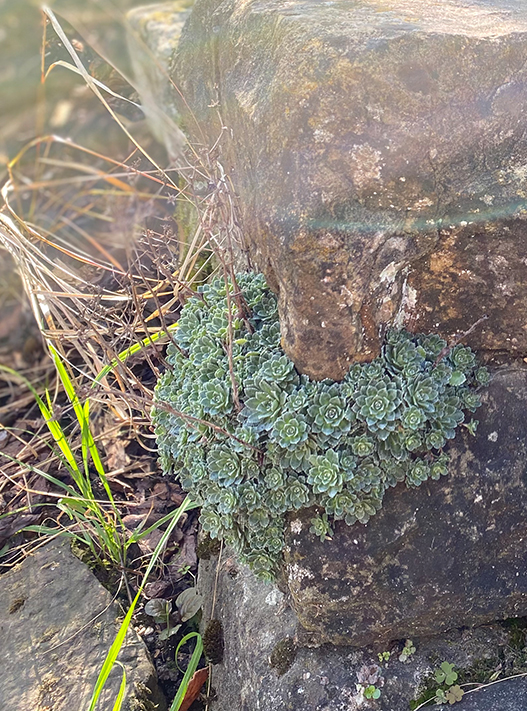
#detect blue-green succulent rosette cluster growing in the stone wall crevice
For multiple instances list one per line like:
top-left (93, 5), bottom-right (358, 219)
top-left (153, 274), bottom-right (490, 578)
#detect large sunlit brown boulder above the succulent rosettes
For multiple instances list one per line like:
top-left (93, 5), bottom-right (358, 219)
top-left (167, 0), bottom-right (527, 379)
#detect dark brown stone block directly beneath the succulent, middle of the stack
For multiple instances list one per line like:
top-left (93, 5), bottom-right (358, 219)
top-left (286, 367), bottom-right (527, 646)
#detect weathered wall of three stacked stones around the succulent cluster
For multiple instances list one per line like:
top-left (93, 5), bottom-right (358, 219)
top-left (130, 0), bottom-right (527, 711)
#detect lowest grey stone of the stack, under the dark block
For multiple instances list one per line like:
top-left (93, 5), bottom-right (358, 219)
top-left (198, 552), bottom-right (527, 711)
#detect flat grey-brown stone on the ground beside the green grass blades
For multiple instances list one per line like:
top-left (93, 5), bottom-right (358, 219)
top-left (0, 541), bottom-right (166, 711)
